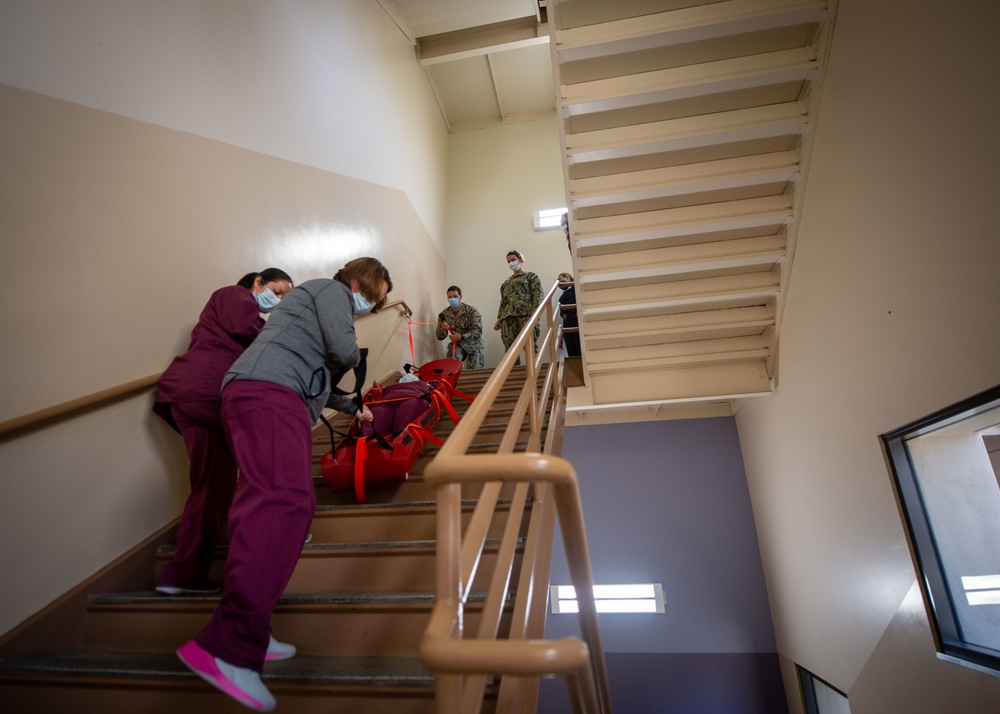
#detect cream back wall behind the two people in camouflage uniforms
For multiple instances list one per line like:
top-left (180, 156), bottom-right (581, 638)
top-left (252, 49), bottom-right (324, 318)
top-left (438, 113), bottom-right (573, 367)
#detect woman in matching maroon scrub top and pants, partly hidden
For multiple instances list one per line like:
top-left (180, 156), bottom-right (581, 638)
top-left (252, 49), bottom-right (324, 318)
top-left (153, 268), bottom-right (293, 595)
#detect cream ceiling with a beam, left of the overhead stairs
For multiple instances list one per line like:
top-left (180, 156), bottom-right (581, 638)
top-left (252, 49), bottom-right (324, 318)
top-left (377, 0), bottom-right (555, 131)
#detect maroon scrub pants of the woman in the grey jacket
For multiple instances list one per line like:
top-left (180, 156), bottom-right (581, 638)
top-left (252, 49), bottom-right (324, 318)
top-left (195, 380), bottom-right (316, 672)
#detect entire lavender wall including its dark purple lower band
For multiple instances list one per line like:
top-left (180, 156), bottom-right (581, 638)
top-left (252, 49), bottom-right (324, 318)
top-left (539, 418), bottom-right (787, 714)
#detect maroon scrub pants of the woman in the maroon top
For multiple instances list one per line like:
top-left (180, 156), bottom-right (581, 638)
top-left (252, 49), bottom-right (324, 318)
top-left (160, 401), bottom-right (236, 587)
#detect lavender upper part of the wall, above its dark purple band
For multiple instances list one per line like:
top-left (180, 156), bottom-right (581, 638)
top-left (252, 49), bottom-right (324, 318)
top-left (546, 417), bottom-right (776, 653)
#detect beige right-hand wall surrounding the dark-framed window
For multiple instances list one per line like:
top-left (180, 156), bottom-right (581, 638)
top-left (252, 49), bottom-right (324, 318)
top-left (737, 0), bottom-right (1000, 714)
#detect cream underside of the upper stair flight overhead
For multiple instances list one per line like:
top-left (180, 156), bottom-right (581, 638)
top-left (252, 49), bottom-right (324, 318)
top-left (546, 0), bottom-right (836, 414)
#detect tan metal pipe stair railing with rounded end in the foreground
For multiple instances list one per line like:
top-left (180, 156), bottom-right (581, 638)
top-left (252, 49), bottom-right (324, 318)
top-left (420, 283), bottom-right (611, 714)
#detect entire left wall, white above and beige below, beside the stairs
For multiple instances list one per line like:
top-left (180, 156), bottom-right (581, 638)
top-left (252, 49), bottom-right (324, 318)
top-left (0, 0), bottom-right (447, 633)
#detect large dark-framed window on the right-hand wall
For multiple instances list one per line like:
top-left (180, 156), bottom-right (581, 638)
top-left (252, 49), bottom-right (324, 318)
top-left (882, 386), bottom-right (1000, 675)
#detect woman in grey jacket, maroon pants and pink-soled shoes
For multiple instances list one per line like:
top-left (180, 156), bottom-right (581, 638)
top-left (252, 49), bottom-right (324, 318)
top-left (177, 258), bottom-right (392, 711)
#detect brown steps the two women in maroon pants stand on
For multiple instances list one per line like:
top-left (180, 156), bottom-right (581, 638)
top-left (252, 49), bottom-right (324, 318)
top-left (0, 368), bottom-right (531, 714)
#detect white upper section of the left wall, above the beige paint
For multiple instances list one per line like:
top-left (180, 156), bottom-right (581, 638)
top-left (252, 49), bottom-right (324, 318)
top-left (0, 0), bottom-right (448, 249)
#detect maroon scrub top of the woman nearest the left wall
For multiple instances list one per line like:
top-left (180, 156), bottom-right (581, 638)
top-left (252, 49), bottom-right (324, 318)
top-left (153, 285), bottom-right (264, 431)
